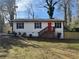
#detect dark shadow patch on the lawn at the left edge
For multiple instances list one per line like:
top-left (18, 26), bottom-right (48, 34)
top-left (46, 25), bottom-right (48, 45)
top-left (0, 37), bottom-right (24, 49)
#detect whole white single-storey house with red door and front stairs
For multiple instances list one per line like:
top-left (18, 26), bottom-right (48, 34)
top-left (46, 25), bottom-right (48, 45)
top-left (10, 19), bottom-right (64, 38)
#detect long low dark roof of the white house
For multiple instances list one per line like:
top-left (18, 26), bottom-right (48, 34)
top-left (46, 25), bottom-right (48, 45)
top-left (10, 19), bottom-right (64, 22)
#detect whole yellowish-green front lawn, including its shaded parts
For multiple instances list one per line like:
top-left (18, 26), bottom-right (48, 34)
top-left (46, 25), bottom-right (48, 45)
top-left (0, 37), bottom-right (79, 59)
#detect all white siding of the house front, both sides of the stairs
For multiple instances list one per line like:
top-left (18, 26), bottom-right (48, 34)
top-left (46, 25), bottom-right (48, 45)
top-left (13, 22), bottom-right (63, 38)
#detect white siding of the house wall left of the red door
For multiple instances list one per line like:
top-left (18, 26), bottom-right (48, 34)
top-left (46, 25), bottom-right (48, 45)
top-left (13, 22), bottom-right (47, 36)
